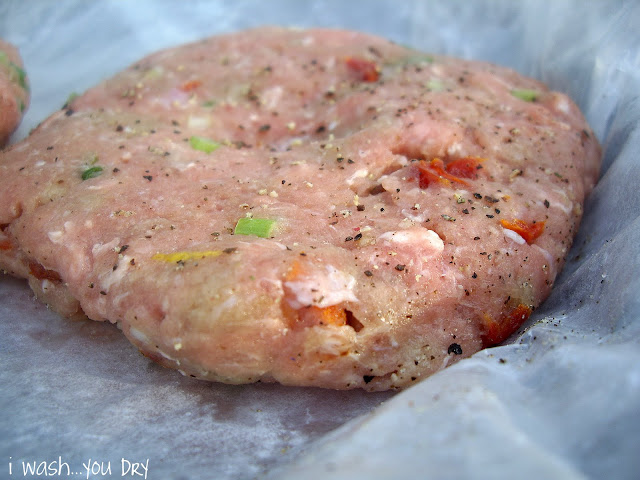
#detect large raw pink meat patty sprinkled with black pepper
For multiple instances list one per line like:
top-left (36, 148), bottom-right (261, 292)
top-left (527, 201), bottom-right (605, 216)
top-left (0, 28), bottom-right (600, 390)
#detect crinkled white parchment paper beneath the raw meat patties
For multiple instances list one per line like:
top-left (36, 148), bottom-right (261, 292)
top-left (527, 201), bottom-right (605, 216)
top-left (0, 0), bottom-right (640, 480)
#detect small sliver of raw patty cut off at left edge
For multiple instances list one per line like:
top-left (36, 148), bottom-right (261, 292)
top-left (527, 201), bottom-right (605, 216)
top-left (0, 40), bottom-right (29, 147)
